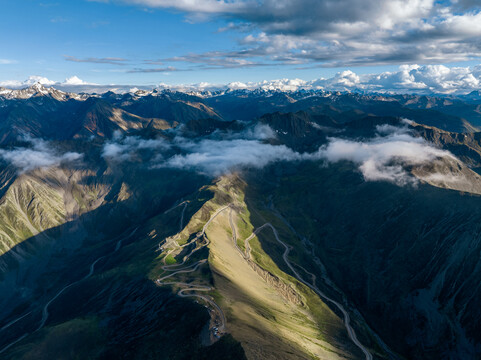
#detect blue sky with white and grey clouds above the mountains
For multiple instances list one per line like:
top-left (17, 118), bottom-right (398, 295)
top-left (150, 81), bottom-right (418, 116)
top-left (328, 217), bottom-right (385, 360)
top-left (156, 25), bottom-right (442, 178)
top-left (0, 0), bottom-right (481, 92)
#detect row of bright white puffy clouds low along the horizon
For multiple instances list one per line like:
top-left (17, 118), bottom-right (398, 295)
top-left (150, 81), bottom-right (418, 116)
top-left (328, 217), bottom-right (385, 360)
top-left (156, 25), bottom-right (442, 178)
top-left (0, 64), bottom-right (481, 94)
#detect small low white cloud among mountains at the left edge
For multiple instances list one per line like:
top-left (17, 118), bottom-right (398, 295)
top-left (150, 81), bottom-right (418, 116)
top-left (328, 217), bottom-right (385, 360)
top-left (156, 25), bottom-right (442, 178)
top-left (0, 138), bottom-right (83, 173)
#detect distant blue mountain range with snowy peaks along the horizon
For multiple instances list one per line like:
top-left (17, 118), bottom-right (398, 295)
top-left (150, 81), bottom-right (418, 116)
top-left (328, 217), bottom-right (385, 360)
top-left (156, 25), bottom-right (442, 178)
top-left (0, 83), bottom-right (481, 143)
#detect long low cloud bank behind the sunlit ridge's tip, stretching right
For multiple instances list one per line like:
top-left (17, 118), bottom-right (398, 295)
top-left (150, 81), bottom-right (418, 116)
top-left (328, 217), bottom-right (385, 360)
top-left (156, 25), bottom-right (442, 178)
top-left (103, 123), bottom-right (458, 186)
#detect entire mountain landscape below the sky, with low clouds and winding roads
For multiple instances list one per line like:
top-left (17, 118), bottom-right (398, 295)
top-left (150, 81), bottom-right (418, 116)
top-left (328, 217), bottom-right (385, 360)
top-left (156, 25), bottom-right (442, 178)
top-left (0, 84), bottom-right (481, 359)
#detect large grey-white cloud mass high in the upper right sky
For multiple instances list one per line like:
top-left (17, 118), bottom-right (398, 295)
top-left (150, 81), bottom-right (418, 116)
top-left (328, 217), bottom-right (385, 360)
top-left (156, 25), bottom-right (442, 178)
top-left (107, 0), bottom-right (481, 67)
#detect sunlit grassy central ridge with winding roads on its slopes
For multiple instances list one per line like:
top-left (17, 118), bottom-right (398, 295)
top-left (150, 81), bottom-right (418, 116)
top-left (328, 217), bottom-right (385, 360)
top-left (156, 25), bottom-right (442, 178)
top-left (153, 175), bottom-right (364, 359)
